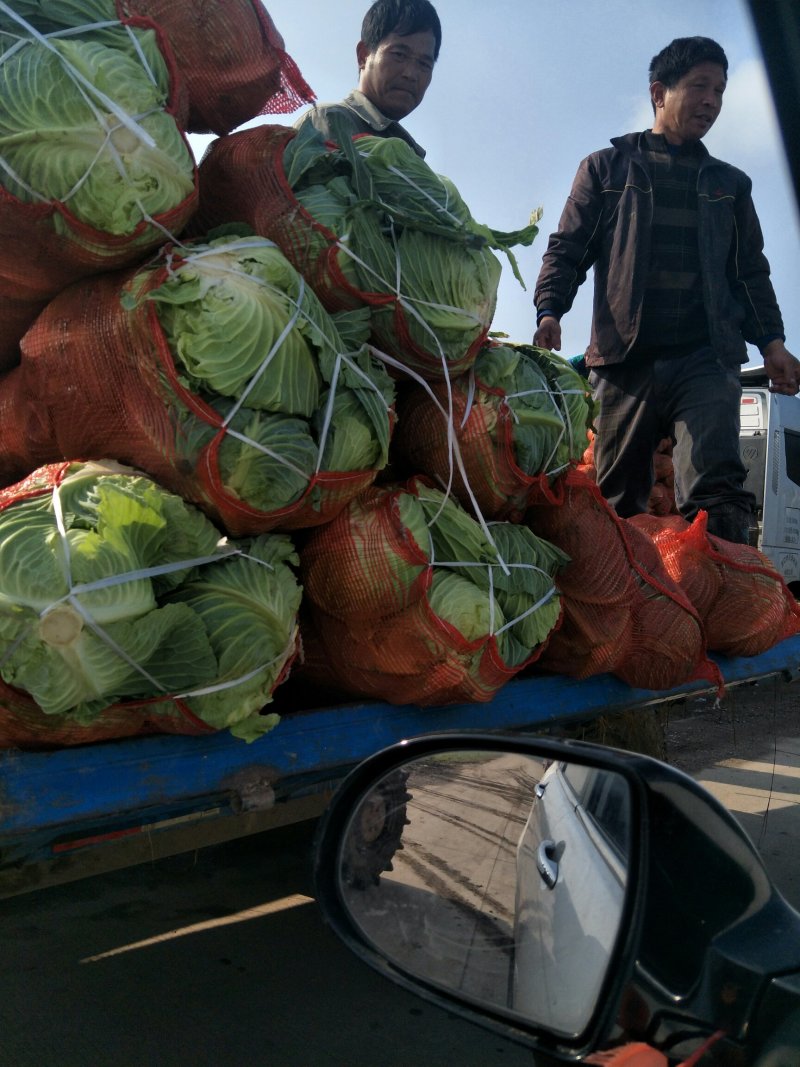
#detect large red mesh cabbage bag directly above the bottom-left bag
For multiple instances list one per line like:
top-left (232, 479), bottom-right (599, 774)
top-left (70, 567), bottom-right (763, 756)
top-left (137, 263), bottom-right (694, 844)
top-left (0, 236), bottom-right (394, 536)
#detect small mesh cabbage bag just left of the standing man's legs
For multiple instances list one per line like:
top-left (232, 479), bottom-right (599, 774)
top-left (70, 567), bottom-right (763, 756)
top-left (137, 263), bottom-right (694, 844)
top-left (393, 343), bottom-right (592, 522)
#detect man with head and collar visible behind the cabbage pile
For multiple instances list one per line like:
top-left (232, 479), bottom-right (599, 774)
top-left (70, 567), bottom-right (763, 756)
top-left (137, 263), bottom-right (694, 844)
top-left (294, 0), bottom-right (442, 157)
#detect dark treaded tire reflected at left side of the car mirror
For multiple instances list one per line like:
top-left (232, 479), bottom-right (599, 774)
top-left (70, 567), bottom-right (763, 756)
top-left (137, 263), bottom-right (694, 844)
top-left (341, 769), bottom-right (411, 889)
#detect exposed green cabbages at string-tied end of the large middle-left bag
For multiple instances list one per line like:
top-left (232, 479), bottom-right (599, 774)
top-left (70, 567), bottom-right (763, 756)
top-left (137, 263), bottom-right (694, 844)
top-left (145, 236), bottom-right (395, 511)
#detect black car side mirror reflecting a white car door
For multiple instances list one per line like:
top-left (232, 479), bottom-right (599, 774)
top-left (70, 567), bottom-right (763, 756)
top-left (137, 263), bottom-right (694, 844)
top-left (315, 734), bottom-right (800, 1063)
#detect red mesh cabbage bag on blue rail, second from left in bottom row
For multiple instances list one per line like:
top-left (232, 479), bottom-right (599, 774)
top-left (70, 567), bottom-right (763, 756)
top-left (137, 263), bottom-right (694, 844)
top-left (299, 478), bottom-right (565, 706)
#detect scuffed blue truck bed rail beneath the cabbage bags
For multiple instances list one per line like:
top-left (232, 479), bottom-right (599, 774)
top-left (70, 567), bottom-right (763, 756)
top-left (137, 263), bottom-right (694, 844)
top-left (0, 635), bottom-right (800, 887)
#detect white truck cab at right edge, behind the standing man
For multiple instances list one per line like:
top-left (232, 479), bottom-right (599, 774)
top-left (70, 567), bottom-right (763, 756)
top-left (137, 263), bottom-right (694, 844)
top-left (740, 367), bottom-right (800, 592)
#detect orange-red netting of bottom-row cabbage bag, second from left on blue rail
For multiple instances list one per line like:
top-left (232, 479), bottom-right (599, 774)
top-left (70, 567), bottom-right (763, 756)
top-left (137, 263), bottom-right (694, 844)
top-left (299, 488), bottom-right (544, 706)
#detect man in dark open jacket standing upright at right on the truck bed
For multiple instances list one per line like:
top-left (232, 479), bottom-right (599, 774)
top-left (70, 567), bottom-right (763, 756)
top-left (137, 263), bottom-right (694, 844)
top-left (533, 37), bottom-right (800, 542)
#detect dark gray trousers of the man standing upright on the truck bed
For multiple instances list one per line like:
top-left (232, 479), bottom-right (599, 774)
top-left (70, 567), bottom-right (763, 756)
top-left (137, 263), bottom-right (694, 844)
top-left (589, 347), bottom-right (755, 543)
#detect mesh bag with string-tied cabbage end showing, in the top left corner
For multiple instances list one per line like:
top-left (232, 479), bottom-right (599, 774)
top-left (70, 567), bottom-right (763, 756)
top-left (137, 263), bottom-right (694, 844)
top-left (0, 2), bottom-right (197, 368)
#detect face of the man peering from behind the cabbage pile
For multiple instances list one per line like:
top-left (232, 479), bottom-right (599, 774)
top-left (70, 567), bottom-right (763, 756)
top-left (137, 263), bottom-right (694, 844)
top-left (355, 30), bottom-right (436, 120)
